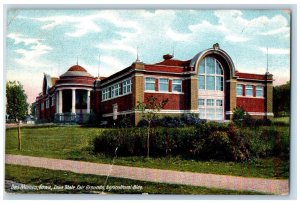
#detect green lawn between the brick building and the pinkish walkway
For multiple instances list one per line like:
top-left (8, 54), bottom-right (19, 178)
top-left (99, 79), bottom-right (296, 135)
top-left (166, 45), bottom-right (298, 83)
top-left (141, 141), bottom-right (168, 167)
top-left (6, 126), bottom-right (289, 178)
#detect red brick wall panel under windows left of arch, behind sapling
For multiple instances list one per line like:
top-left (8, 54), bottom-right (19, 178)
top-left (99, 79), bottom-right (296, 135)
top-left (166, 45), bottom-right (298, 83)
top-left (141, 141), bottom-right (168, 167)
top-left (144, 93), bottom-right (186, 110)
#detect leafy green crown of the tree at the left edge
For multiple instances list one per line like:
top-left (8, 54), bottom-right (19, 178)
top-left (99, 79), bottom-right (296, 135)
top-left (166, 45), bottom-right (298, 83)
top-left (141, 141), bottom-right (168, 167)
top-left (6, 81), bottom-right (28, 121)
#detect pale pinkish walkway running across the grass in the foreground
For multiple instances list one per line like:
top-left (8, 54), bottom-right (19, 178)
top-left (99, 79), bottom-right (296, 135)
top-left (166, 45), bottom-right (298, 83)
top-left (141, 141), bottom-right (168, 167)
top-left (5, 155), bottom-right (289, 195)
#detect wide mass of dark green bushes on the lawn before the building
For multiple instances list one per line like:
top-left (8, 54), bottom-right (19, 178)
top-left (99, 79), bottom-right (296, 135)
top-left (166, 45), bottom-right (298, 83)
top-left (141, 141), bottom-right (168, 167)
top-left (93, 122), bottom-right (262, 161)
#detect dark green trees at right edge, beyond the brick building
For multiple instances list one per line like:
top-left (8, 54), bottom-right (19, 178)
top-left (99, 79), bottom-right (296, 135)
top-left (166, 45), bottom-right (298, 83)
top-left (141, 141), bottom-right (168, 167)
top-left (273, 81), bottom-right (291, 116)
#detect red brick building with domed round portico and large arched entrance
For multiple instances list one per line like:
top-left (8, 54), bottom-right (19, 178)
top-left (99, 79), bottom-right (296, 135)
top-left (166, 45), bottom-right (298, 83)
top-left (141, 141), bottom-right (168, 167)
top-left (36, 44), bottom-right (273, 123)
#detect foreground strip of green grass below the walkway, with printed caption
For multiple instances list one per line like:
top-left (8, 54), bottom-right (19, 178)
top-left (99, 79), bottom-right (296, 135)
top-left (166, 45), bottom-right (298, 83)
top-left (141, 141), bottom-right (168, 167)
top-left (5, 165), bottom-right (261, 195)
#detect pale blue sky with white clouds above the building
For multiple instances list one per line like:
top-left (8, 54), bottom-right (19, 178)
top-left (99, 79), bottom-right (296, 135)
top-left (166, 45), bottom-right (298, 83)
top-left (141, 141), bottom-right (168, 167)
top-left (5, 9), bottom-right (290, 103)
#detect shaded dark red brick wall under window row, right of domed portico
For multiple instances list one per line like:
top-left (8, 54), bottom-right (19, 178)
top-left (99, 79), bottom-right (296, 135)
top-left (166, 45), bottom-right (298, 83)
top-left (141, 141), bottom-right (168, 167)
top-left (101, 94), bottom-right (133, 114)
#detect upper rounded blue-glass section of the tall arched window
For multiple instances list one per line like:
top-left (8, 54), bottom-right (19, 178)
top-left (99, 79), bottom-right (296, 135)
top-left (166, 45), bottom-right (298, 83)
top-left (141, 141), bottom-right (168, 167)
top-left (198, 57), bottom-right (224, 91)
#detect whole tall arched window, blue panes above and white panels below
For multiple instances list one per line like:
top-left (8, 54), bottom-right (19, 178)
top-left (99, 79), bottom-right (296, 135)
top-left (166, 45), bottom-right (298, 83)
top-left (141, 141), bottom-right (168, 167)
top-left (198, 57), bottom-right (224, 120)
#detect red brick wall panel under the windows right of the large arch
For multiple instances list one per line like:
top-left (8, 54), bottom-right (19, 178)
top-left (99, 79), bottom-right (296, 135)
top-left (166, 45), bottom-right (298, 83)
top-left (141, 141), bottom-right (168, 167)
top-left (236, 97), bottom-right (265, 112)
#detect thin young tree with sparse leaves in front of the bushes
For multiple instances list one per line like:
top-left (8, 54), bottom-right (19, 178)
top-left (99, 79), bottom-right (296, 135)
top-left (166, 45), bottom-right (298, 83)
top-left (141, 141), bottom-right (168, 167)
top-left (136, 95), bottom-right (168, 158)
